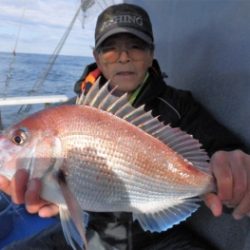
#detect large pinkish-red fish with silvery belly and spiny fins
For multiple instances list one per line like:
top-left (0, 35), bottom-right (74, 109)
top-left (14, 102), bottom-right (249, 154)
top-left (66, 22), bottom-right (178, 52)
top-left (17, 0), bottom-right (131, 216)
top-left (0, 80), bottom-right (215, 249)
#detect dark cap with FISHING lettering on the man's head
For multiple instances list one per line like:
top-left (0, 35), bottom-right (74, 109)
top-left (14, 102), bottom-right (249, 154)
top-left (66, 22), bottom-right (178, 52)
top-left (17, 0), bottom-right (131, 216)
top-left (95, 3), bottom-right (154, 48)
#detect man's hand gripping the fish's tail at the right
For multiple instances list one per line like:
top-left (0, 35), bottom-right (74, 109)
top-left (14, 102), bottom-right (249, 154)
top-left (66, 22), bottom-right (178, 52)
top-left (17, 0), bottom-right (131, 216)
top-left (204, 150), bottom-right (250, 219)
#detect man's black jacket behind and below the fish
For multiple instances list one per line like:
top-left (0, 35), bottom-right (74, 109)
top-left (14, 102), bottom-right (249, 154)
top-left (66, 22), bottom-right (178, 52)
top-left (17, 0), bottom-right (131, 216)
top-left (75, 60), bottom-right (243, 249)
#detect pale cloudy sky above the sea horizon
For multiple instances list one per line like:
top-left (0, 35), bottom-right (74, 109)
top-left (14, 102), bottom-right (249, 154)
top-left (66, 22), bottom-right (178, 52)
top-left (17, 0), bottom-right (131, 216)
top-left (0, 0), bottom-right (121, 56)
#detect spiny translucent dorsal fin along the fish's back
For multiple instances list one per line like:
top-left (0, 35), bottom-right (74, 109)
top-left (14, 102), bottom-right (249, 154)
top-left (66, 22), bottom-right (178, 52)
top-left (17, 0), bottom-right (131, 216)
top-left (83, 81), bottom-right (209, 172)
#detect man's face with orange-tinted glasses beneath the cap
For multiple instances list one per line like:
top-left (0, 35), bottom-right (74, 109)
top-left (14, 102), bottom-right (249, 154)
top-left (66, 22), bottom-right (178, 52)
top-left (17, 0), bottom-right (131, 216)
top-left (94, 34), bottom-right (153, 92)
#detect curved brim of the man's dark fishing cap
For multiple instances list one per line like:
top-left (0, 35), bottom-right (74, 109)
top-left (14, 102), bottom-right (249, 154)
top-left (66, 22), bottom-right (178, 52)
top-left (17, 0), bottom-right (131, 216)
top-left (95, 27), bottom-right (153, 48)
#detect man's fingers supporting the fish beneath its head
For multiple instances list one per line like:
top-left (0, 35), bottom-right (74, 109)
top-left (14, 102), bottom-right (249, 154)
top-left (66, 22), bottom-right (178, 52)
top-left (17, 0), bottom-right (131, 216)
top-left (0, 169), bottom-right (58, 217)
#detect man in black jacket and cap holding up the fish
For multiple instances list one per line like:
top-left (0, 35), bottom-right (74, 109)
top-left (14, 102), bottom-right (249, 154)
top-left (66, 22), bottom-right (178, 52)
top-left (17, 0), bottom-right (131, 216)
top-left (0, 4), bottom-right (250, 249)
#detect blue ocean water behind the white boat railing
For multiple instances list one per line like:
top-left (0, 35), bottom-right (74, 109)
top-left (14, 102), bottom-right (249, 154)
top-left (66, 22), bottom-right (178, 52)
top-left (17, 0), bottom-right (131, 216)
top-left (0, 52), bottom-right (93, 127)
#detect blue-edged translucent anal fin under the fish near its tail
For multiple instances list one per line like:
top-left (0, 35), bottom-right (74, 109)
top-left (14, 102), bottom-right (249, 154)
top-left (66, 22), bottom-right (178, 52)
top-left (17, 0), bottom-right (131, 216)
top-left (133, 198), bottom-right (199, 232)
